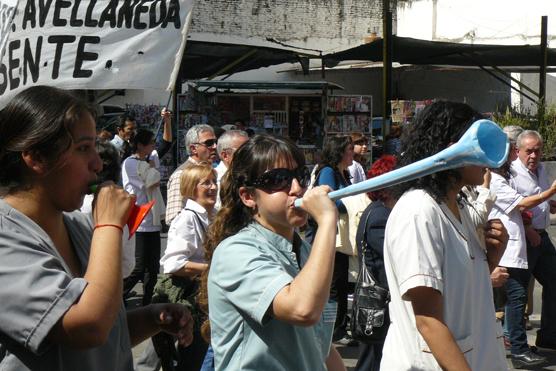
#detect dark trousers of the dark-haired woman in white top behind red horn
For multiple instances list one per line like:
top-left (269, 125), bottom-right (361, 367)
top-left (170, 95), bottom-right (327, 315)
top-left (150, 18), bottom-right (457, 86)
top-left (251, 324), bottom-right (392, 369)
top-left (124, 232), bottom-right (160, 305)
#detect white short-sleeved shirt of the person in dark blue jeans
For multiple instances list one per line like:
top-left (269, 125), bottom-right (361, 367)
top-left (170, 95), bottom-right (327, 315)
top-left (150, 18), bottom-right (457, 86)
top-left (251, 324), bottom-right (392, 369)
top-left (488, 173), bottom-right (528, 269)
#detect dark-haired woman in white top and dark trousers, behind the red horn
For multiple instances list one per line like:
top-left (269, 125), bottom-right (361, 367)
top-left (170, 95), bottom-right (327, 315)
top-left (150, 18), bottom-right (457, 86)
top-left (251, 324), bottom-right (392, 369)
top-left (122, 129), bottom-right (165, 305)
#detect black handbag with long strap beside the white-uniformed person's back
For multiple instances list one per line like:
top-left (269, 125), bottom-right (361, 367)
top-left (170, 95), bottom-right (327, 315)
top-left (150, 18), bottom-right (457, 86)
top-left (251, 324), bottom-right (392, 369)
top-left (350, 213), bottom-right (390, 344)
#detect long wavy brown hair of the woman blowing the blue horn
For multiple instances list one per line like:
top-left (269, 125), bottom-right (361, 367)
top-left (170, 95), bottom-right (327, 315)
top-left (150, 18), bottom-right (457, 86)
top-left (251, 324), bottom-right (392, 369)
top-left (197, 134), bottom-right (305, 341)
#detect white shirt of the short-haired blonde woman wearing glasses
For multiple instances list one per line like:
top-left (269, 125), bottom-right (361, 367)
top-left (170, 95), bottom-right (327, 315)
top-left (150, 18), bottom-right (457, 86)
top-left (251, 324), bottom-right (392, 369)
top-left (160, 199), bottom-right (209, 273)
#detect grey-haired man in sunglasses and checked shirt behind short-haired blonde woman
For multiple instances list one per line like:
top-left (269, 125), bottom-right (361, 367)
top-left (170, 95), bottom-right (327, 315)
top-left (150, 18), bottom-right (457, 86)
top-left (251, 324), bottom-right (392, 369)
top-left (166, 124), bottom-right (217, 225)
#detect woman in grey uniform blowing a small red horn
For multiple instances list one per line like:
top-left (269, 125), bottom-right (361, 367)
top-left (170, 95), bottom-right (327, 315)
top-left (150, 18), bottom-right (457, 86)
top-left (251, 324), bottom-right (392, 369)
top-left (0, 86), bottom-right (192, 371)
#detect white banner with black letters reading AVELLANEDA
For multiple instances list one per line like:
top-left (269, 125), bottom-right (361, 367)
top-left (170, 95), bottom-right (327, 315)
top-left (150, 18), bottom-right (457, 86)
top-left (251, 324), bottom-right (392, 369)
top-left (0, 0), bottom-right (194, 107)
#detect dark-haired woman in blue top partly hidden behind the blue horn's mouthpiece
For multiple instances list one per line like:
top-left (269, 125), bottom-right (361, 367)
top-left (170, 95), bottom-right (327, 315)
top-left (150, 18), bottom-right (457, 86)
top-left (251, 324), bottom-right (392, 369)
top-left (305, 136), bottom-right (357, 345)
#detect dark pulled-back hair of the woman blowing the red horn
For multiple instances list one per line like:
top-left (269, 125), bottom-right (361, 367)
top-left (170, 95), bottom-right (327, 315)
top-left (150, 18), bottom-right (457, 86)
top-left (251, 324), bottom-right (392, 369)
top-left (0, 85), bottom-right (94, 194)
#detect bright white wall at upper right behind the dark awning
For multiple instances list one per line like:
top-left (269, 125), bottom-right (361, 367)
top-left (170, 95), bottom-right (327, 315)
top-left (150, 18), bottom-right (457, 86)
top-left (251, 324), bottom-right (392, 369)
top-left (398, 0), bottom-right (556, 113)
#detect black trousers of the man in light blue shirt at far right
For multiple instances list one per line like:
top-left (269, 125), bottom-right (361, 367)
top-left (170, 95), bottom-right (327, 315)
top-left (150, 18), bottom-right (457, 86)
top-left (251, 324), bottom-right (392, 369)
top-left (527, 231), bottom-right (556, 342)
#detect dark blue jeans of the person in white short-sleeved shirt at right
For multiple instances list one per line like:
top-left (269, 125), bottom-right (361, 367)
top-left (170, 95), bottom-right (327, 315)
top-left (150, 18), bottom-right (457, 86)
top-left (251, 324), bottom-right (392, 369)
top-left (504, 268), bottom-right (531, 354)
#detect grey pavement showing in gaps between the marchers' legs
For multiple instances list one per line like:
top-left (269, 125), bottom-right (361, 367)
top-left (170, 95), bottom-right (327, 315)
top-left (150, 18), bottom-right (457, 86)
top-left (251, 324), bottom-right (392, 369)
top-left (127, 227), bottom-right (556, 371)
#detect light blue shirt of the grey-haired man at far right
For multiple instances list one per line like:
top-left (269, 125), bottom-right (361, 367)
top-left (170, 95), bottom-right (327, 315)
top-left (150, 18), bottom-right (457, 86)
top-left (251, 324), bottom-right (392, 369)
top-left (510, 158), bottom-right (550, 229)
